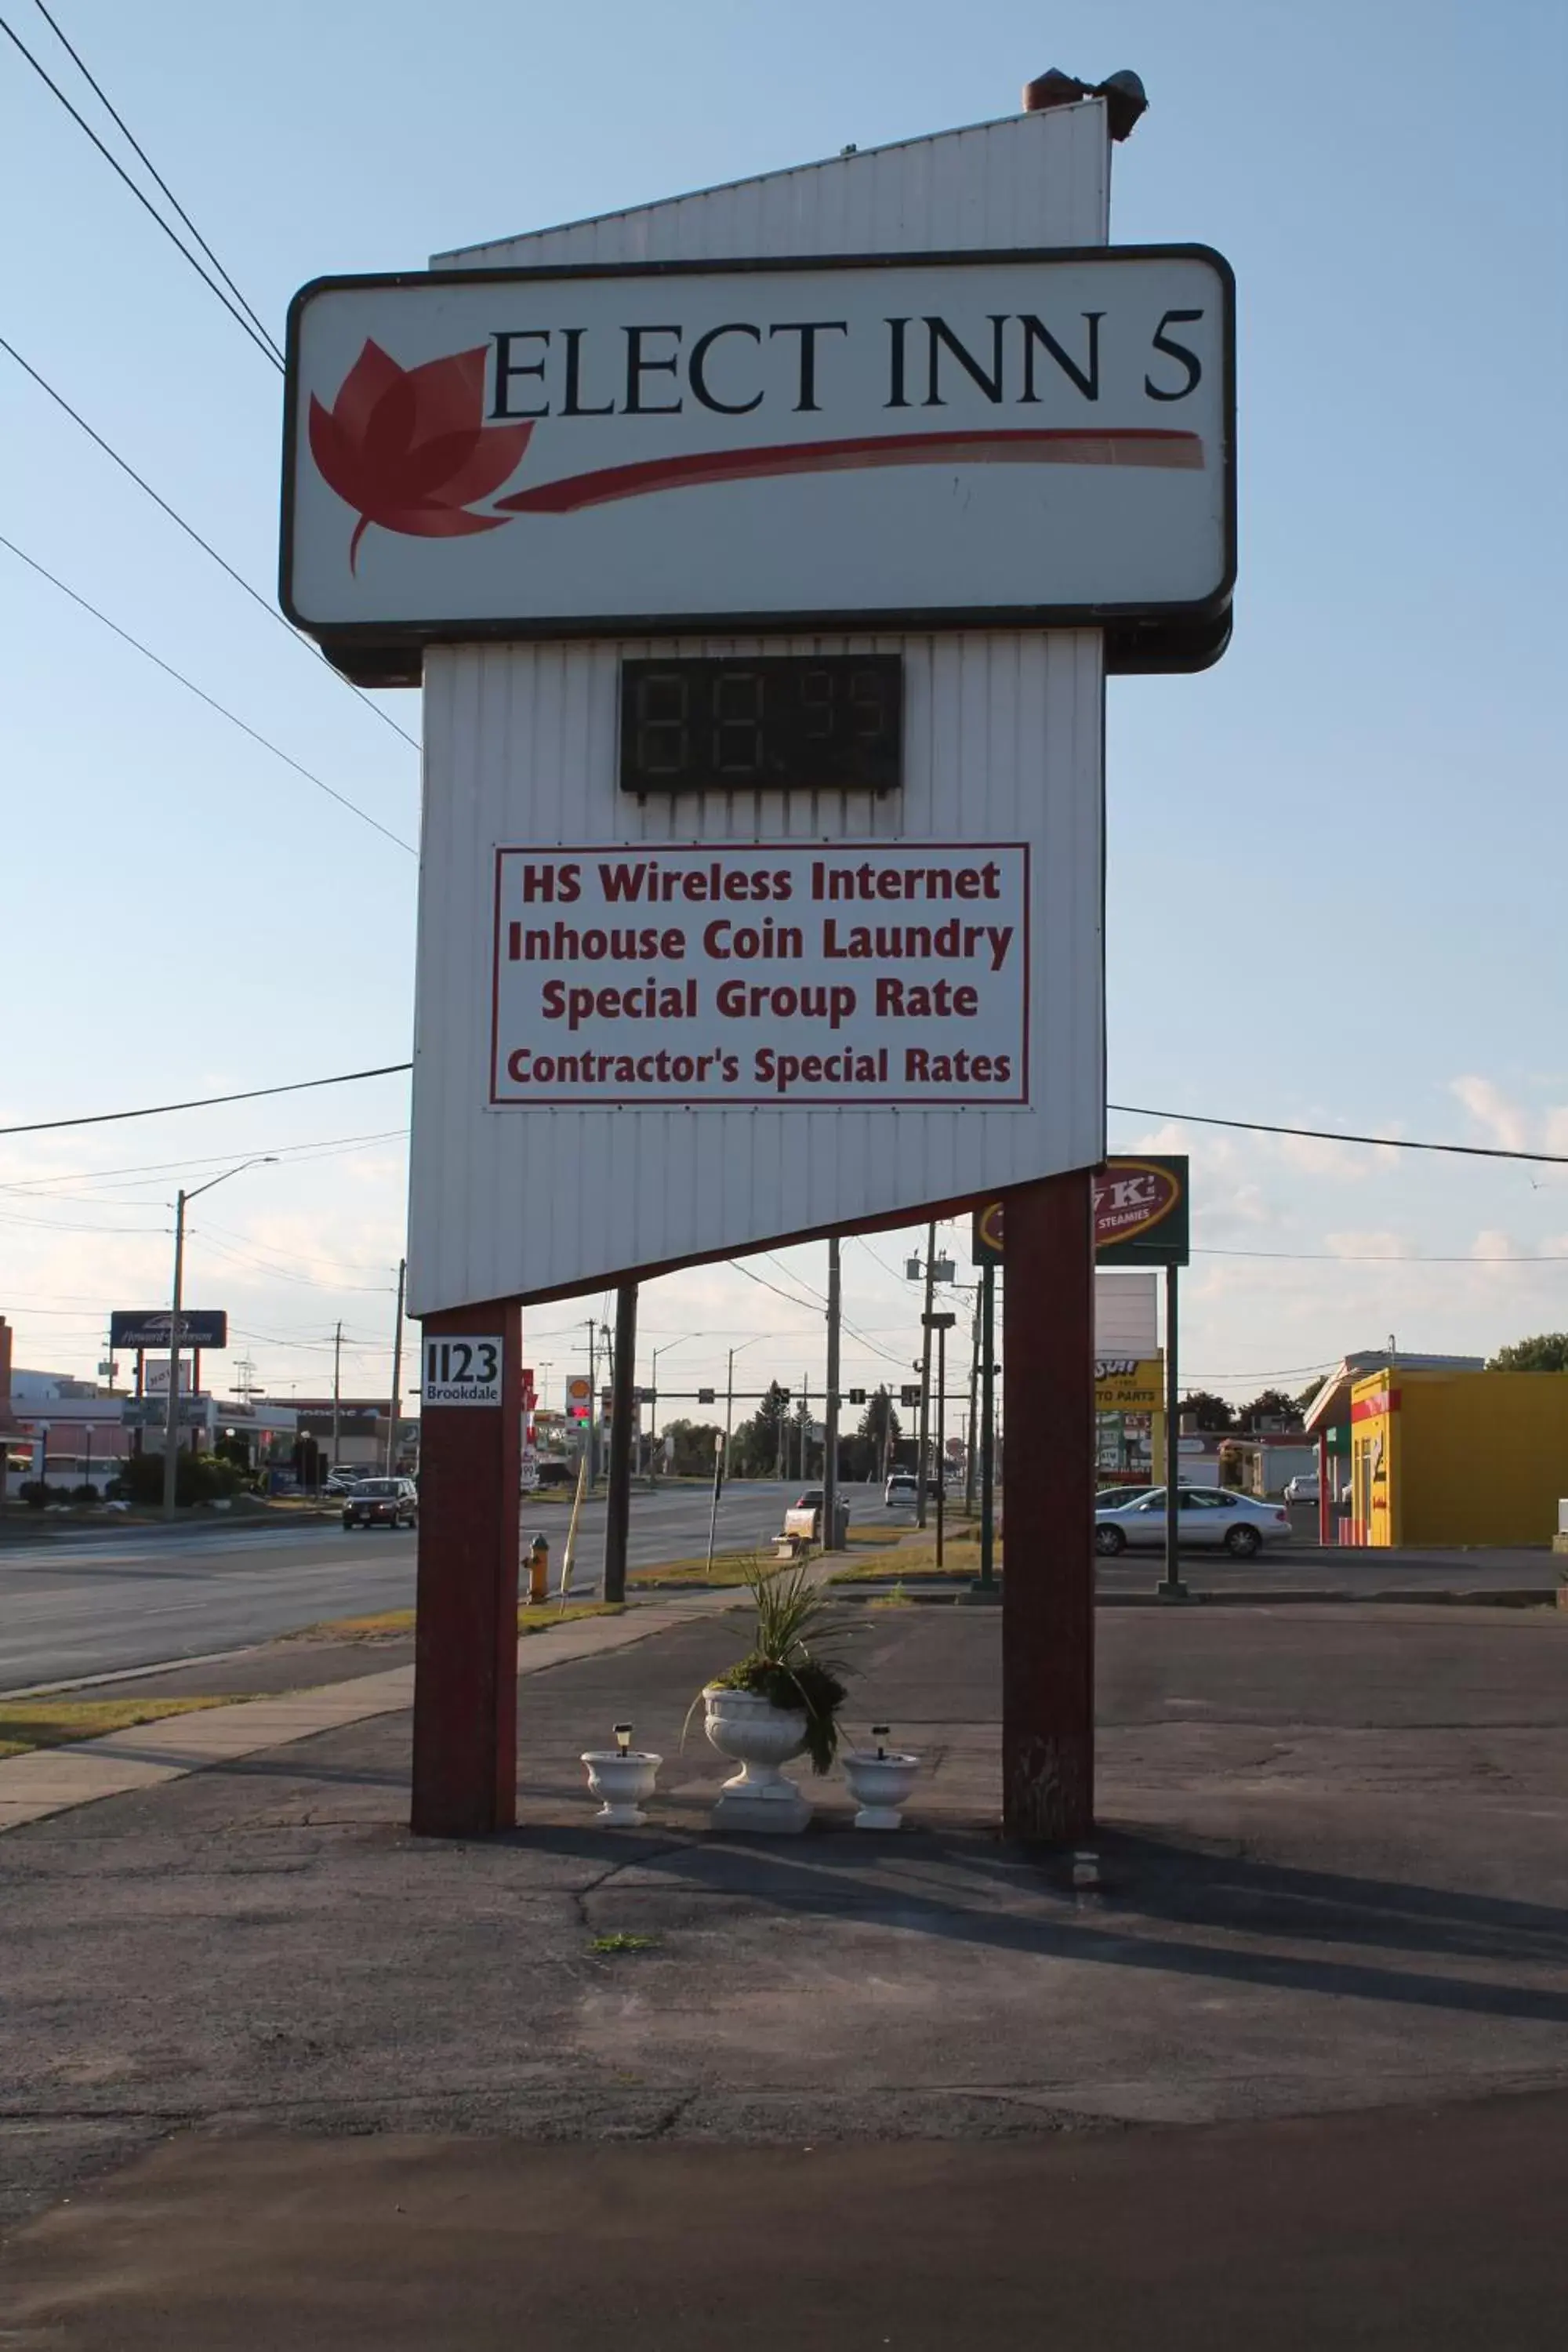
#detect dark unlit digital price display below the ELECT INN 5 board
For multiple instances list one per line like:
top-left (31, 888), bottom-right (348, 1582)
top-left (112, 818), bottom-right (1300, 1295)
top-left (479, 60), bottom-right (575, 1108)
top-left (621, 654), bottom-right (902, 793)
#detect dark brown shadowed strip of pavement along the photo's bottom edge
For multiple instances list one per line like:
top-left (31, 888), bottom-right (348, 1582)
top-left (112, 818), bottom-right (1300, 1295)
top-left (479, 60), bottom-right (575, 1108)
top-left (5, 2096), bottom-right (1568, 2352)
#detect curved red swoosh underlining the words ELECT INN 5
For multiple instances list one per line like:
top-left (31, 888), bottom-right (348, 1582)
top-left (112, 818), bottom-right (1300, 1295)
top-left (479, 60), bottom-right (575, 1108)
top-left (496, 426), bottom-right (1203, 515)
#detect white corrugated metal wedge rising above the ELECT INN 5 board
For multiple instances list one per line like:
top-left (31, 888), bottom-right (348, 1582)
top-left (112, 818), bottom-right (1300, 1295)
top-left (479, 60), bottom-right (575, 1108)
top-left (430, 99), bottom-right (1109, 270)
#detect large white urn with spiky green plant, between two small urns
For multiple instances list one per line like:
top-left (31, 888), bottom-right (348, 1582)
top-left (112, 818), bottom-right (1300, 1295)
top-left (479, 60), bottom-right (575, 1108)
top-left (687, 1566), bottom-right (846, 1835)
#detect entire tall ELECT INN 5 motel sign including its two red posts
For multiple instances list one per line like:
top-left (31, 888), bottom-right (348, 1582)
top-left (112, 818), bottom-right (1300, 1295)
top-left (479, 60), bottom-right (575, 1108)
top-left (282, 82), bottom-right (1234, 1835)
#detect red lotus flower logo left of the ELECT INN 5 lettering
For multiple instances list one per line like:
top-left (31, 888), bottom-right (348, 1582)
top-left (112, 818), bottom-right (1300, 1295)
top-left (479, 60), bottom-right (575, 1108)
top-left (310, 341), bottom-right (534, 572)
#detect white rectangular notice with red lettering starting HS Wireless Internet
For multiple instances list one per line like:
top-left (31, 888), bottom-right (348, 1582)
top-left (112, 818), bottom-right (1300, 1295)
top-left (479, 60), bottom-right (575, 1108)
top-left (489, 840), bottom-right (1029, 1110)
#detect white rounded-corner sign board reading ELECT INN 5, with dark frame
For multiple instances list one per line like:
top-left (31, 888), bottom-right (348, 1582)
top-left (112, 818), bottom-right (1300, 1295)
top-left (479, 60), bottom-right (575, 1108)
top-left (282, 247), bottom-right (1234, 647)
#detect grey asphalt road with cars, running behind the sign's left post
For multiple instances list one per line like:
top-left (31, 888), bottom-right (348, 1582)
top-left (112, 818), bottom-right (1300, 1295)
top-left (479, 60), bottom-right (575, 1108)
top-left (0, 1482), bottom-right (881, 1691)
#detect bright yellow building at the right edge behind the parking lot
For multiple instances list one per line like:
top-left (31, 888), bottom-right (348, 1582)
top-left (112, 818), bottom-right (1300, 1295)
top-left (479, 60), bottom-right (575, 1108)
top-left (1349, 1362), bottom-right (1568, 1548)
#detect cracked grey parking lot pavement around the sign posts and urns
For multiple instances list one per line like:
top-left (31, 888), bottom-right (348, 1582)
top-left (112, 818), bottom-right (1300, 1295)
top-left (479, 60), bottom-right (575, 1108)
top-left (0, 1604), bottom-right (1568, 2216)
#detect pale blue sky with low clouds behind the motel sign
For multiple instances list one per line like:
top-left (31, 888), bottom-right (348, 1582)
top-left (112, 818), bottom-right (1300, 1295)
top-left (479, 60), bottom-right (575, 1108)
top-left (0, 0), bottom-right (1568, 1395)
